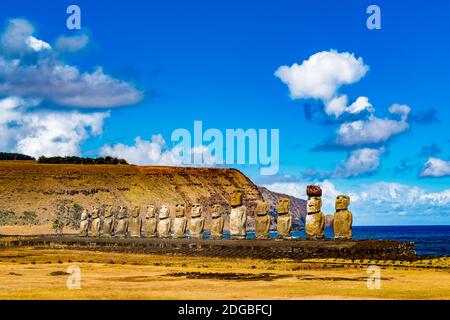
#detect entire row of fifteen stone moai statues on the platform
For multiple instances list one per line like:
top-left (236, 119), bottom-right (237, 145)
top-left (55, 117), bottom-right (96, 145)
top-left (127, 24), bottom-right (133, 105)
top-left (80, 186), bottom-right (352, 239)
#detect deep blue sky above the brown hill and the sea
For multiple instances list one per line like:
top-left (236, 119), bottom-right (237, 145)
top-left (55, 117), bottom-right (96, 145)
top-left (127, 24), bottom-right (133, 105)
top-left (0, 0), bottom-right (450, 225)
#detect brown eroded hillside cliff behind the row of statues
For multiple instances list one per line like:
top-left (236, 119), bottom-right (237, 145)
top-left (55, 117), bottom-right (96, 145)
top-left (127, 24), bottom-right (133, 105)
top-left (0, 161), bottom-right (301, 227)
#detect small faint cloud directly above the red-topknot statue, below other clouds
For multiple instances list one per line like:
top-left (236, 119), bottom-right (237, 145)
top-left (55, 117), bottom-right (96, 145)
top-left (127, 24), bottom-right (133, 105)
top-left (334, 148), bottom-right (384, 178)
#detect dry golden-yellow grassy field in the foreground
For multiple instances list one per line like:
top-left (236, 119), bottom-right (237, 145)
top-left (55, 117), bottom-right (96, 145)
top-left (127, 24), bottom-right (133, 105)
top-left (0, 248), bottom-right (450, 299)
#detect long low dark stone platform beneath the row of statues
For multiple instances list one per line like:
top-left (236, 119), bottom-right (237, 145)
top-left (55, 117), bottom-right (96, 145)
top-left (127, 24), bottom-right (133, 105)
top-left (0, 235), bottom-right (417, 260)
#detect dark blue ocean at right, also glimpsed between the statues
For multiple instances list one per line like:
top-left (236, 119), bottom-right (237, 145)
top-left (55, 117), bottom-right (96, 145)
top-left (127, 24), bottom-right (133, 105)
top-left (218, 226), bottom-right (450, 257)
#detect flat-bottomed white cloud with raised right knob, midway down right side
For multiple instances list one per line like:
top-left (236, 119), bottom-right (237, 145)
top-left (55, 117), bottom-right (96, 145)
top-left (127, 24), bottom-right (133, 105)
top-left (336, 105), bottom-right (410, 146)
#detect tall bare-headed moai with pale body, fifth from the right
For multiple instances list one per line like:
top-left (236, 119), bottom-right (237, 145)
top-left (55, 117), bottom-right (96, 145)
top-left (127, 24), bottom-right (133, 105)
top-left (230, 189), bottom-right (247, 239)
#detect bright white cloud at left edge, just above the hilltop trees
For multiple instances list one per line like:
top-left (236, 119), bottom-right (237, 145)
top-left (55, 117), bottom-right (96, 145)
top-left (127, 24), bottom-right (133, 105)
top-left (0, 97), bottom-right (109, 157)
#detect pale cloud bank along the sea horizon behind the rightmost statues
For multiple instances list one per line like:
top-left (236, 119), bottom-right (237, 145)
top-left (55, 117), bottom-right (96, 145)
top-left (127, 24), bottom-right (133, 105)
top-left (264, 180), bottom-right (450, 225)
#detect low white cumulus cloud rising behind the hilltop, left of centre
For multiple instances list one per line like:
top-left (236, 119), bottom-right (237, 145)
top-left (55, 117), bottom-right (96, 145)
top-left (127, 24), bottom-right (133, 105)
top-left (100, 134), bottom-right (217, 166)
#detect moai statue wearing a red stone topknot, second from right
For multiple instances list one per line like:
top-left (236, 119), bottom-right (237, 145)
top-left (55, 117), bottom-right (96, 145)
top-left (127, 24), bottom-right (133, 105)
top-left (305, 186), bottom-right (325, 240)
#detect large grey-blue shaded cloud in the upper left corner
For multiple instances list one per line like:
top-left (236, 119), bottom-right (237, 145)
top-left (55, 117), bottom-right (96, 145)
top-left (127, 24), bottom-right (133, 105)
top-left (0, 19), bottom-right (143, 108)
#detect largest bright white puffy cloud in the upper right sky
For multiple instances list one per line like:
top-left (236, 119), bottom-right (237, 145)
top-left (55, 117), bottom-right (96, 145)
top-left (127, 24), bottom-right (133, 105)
top-left (275, 50), bottom-right (369, 101)
